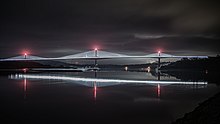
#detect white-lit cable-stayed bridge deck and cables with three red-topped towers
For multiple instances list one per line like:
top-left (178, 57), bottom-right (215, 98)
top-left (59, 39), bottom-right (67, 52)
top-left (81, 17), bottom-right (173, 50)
top-left (0, 49), bottom-right (208, 61)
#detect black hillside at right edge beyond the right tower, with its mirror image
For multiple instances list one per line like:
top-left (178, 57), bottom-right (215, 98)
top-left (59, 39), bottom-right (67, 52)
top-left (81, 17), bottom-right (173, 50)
top-left (160, 56), bottom-right (220, 84)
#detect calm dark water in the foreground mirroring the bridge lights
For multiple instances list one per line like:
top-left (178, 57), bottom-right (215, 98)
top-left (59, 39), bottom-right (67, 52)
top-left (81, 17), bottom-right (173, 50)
top-left (0, 71), bottom-right (220, 124)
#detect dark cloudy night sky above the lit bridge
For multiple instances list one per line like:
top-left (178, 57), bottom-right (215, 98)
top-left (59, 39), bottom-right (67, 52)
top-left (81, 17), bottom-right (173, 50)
top-left (0, 0), bottom-right (220, 58)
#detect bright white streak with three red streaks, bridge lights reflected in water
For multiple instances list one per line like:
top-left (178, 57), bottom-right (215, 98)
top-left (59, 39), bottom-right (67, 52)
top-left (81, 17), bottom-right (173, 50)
top-left (8, 72), bottom-right (208, 100)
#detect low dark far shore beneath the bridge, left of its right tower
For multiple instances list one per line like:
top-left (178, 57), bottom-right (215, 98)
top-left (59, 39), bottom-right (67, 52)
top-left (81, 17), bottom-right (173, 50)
top-left (0, 61), bottom-right (160, 71)
